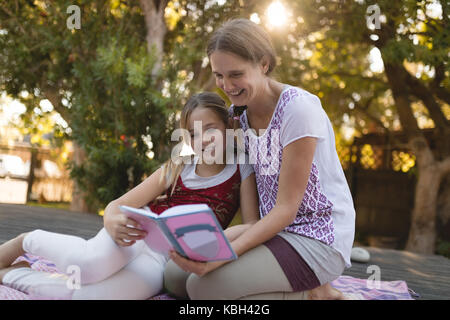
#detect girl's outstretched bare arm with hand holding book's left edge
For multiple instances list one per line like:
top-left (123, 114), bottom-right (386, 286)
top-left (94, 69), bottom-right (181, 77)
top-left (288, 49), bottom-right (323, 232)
top-left (103, 168), bottom-right (167, 247)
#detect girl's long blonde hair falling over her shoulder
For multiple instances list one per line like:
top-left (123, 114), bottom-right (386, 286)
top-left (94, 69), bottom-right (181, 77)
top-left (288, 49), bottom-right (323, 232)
top-left (161, 92), bottom-right (229, 194)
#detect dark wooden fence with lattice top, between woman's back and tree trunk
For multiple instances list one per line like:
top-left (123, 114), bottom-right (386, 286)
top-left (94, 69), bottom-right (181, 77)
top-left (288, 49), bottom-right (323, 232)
top-left (345, 129), bottom-right (439, 249)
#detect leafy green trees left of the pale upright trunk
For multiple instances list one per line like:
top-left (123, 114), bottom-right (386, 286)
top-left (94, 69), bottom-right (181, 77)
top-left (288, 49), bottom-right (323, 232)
top-left (0, 0), bottom-right (170, 211)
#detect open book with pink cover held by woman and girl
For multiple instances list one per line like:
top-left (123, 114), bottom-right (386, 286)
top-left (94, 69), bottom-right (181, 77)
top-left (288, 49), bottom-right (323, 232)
top-left (119, 204), bottom-right (237, 261)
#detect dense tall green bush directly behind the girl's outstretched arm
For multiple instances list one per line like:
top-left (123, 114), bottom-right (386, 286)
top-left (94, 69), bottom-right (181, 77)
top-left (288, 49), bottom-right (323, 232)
top-left (65, 20), bottom-right (169, 211)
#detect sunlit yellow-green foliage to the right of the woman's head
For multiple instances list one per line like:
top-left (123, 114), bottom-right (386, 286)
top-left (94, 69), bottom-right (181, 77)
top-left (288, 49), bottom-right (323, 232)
top-left (276, 0), bottom-right (450, 133)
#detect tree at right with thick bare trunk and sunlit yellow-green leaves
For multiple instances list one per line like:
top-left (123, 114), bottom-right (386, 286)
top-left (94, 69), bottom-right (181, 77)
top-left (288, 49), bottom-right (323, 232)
top-left (274, 0), bottom-right (450, 253)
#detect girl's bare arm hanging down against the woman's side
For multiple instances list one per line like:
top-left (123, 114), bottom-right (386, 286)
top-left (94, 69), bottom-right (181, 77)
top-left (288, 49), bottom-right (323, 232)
top-left (224, 173), bottom-right (259, 241)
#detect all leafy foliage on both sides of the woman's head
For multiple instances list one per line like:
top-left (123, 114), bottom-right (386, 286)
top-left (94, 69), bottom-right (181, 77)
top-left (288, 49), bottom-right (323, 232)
top-left (0, 0), bottom-right (450, 212)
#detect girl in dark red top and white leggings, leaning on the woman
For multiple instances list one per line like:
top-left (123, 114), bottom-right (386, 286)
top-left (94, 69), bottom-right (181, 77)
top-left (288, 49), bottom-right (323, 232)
top-left (0, 93), bottom-right (258, 299)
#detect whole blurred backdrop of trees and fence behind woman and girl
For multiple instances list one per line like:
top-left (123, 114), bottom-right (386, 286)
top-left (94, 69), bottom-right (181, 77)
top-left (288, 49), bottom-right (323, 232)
top-left (0, 0), bottom-right (450, 257)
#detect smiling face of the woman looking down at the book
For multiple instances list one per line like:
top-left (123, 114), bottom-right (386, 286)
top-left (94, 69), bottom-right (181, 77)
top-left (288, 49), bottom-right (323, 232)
top-left (209, 50), bottom-right (269, 106)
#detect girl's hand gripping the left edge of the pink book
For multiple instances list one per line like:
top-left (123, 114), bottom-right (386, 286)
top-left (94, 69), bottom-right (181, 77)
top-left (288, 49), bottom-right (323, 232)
top-left (103, 212), bottom-right (147, 247)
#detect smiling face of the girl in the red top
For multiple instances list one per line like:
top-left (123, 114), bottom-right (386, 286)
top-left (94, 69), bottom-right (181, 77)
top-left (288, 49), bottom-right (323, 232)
top-left (187, 107), bottom-right (227, 163)
